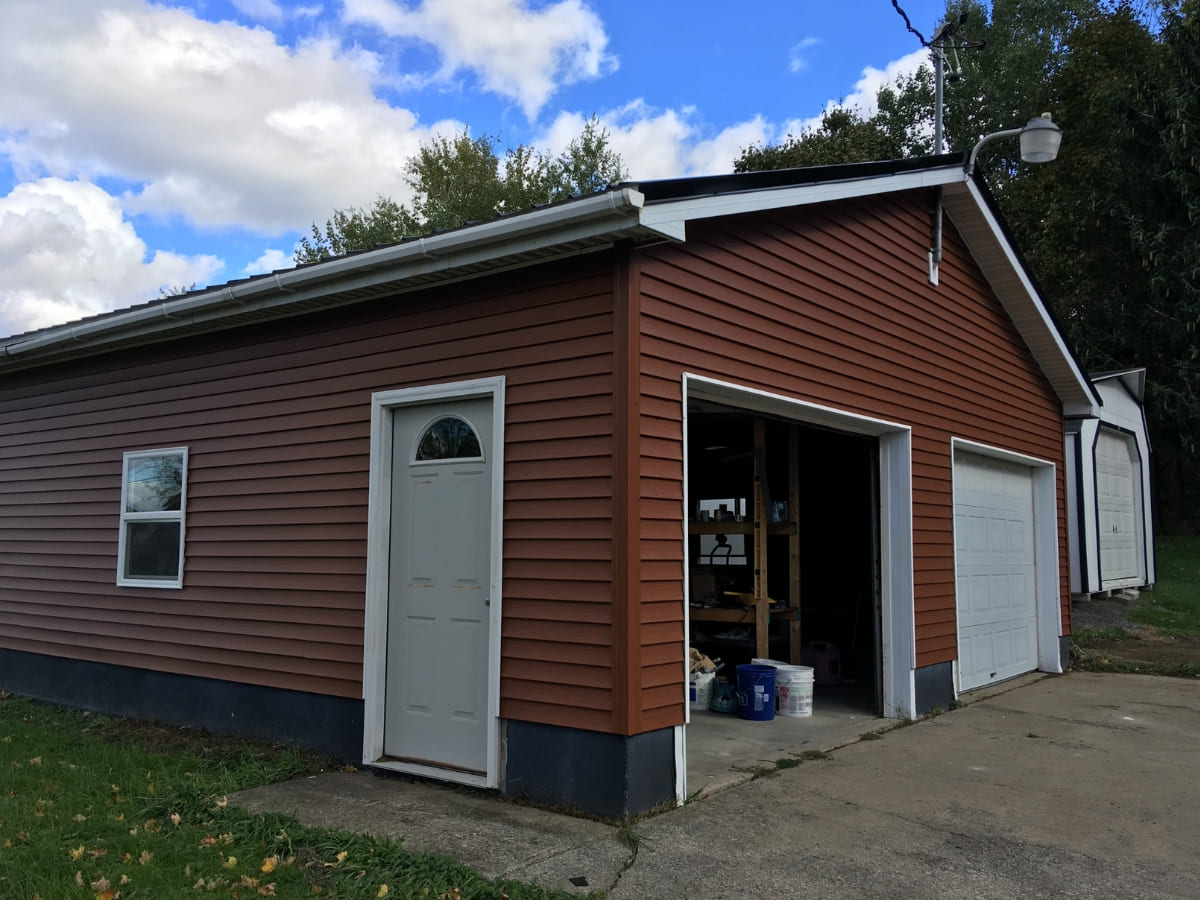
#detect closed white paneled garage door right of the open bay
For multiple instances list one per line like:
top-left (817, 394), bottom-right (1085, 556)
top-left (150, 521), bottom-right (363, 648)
top-left (954, 452), bottom-right (1038, 690)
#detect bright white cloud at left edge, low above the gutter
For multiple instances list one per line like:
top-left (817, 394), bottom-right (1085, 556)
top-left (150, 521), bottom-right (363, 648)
top-left (0, 178), bottom-right (222, 335)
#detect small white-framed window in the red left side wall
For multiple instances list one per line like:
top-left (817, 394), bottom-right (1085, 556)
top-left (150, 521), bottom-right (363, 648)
top-left (116, 446), bottom-right (187, 588)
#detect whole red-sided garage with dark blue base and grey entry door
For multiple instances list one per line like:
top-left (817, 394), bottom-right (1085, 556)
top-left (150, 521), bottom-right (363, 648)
top-left (0, 156), bottom-right (1099, 818)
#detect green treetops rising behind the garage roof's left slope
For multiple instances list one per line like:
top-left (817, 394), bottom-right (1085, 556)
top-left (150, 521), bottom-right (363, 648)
top-left (295, 118), bottom-right (628, 264)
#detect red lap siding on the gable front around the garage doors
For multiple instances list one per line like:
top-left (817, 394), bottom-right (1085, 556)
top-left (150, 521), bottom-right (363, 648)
top-left (640, 193), bottom-right (1067, 676)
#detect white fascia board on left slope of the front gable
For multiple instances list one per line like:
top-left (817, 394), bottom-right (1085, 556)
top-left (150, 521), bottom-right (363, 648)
top-left (638, 164), bottom-right (962, 240)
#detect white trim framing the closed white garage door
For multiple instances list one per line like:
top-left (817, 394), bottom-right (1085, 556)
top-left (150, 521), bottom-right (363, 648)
top-left (950, 438), bottom-right (1062, 696)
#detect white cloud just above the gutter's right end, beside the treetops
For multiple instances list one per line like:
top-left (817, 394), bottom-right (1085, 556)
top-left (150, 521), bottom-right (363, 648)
top-left (536, 100), bottom-right (773, 180)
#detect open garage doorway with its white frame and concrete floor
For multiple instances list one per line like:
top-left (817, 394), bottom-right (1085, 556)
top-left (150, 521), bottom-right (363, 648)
top-left (680, 376), bottom-right (913, 792)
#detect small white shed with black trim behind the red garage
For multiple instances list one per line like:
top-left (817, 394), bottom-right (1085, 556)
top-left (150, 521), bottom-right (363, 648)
top-left (1067, 368), bottom-right (1154, 595)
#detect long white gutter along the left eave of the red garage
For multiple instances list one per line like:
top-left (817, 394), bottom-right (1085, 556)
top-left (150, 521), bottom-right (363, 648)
top-left (0, 187), bottom-right (646, 356)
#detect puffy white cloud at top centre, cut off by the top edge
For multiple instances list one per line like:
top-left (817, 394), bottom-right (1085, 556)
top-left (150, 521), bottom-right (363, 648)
top-left (343, 0), bottom-right (617, 120)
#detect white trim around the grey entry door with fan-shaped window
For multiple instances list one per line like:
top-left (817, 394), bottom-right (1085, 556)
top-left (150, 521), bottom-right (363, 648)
top-left (362, 376), bottom-right (504, 787)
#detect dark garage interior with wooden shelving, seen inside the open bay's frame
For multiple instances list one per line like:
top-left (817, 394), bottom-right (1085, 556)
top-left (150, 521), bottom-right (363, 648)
top-left (688, 410), bottom-right (882, 715)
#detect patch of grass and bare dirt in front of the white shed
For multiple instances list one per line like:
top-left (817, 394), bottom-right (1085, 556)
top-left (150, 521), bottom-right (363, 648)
top-left (1070, 536), bottom-right (1200, 678)
